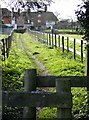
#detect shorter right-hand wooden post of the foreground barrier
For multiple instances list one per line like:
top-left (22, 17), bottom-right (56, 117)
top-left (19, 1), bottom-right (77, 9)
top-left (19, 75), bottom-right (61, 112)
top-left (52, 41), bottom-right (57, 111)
top-left (56, 79), bottom-right (72, 120)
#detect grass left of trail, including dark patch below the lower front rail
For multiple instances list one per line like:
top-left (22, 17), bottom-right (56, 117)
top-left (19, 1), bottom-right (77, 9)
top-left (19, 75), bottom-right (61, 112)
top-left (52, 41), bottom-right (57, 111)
top-left (2, 34), bottom-right (36, 120)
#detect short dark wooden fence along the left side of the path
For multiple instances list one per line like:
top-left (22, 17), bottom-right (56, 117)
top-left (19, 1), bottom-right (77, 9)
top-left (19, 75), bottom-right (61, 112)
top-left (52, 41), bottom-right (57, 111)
top-left (1, 31), bottom-right (13, 61)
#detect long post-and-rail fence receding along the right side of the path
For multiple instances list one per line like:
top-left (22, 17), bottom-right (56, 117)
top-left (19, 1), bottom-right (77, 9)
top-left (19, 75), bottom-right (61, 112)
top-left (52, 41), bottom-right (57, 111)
top-left (29, 30), bottom-right (85, 62)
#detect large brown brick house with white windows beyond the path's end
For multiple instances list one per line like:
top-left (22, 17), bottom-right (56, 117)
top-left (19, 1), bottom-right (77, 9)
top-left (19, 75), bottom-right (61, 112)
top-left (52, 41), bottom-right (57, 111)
top-left (22, 12), bottom-right (58, 29)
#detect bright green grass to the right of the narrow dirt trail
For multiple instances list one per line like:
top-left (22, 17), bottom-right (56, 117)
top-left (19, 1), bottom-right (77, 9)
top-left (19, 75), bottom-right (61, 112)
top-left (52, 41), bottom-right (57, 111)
top-left (23, 33), bottom-right (87, 118)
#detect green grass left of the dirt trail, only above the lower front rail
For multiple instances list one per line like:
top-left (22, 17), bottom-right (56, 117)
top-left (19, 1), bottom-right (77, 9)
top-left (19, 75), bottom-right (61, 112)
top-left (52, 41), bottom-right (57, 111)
top-left (2, 34), bottom-right (35, 90)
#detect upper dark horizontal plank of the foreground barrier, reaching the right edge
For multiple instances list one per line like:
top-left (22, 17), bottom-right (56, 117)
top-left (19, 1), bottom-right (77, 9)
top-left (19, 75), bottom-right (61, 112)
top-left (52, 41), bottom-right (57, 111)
top-left (37, 76), bottom-right (89, 87)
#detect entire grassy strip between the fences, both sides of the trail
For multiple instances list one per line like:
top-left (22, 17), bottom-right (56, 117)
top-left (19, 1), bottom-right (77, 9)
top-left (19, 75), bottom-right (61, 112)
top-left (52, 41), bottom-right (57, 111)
top-left (2, 33), bottom-right (87, 119)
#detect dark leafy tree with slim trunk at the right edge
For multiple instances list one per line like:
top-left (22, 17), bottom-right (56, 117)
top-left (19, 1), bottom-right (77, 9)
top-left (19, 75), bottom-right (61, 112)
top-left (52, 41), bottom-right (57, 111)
top-left (76, 0), bottom-right (89, 115)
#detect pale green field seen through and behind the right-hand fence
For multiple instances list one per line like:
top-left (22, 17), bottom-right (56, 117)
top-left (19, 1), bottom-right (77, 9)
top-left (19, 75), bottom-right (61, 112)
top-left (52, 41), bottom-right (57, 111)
top-left (31, 32), bottom-right (86, 58)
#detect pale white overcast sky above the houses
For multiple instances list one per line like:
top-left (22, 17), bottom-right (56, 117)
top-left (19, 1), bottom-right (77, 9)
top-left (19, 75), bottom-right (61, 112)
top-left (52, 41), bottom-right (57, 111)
top-left (0, 0), bottom-right (82, 20)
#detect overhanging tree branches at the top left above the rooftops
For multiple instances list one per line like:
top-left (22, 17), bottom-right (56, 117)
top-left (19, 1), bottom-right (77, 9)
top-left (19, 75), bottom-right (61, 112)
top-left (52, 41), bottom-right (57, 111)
top-left (0, 0), bottom-right (53, 12)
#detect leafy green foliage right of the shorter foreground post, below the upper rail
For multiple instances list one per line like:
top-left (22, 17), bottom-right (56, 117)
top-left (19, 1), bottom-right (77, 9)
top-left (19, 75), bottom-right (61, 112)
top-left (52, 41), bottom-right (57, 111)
top-left (72, 88), bottom-right (88, 119)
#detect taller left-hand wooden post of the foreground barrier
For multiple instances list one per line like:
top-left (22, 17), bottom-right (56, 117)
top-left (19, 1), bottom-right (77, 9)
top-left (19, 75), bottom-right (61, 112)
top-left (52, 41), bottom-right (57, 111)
top-left (23, 69), bottom-right (36, 120)
